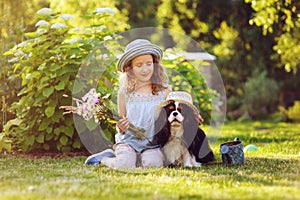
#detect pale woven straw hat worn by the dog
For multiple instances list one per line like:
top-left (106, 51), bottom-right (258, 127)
top-left (159, 91), bottom-right (199, 113)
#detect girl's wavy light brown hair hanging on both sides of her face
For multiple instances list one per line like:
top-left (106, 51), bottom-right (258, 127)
top-left (124, 55), bottom-right (169, 95)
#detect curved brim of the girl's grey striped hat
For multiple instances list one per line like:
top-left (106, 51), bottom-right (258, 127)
top-left (117, 44), bottom-right (163, 72)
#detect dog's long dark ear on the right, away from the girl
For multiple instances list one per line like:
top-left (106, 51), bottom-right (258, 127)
top-left (181, 104), bottom-right (199, 147)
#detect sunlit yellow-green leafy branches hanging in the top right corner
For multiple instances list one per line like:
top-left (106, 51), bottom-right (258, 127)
top-left (245, 0), bottom-right (300, 73)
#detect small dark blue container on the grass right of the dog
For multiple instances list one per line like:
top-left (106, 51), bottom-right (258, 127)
top-left (220, 140), bottom-right (245, 165)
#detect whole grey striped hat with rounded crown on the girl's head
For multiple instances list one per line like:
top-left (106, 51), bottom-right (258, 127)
top-left (117, 39), bottom-right (163, 72)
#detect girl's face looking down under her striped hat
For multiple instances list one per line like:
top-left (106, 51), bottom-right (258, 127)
top-left (131, 54), bottom-right (154, 83)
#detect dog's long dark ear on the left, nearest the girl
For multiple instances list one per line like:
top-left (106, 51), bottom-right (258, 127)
top-left (152, 107), bottom-right (170, 147)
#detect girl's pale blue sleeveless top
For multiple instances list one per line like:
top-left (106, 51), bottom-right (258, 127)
top-left (115, 90), bottom-right (166, 152)
